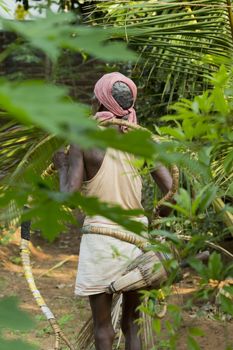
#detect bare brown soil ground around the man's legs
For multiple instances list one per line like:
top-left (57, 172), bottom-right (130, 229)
top-left (0, 233), bottom-right (233, 350)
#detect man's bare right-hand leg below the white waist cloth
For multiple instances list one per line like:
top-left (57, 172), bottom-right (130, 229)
top-left (121, 291), bottom-right (142, 350)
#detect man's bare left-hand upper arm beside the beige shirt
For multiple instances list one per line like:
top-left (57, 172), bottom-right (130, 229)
top-left (53, 145), bottom-right (84, 192)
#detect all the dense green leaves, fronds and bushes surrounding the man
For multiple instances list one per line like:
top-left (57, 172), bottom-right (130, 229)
top-left (0, 0), bottom-right (233, 350)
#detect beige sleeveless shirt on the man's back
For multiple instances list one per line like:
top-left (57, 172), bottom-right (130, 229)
top-left (82, 148), bottom-right (143, 224)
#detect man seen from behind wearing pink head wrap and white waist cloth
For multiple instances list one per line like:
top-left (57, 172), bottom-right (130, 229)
top-left (54, 73), bottom-right (172, 350)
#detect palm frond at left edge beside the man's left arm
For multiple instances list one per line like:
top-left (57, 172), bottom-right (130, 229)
top-left (0, 112), bottom-right (61, 183)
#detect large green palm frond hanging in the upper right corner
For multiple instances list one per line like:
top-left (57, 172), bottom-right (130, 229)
top-left (89, 0), bottom-right (233, 115)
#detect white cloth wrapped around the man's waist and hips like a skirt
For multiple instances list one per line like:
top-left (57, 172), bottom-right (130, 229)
top-left (75, 217), bottom-right (148, 296)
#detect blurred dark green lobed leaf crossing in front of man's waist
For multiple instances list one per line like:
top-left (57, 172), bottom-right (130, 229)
top-left (0, 168), bottom-right (144, 240)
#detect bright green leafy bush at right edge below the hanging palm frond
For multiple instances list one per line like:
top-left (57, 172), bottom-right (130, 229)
top-left (159, 66), bottom-right (233, 194)
